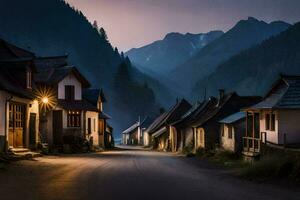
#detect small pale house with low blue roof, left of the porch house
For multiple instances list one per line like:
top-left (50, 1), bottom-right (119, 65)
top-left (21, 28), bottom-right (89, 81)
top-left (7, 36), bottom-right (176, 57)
top-left (219, 111), bottom-right (246, 153)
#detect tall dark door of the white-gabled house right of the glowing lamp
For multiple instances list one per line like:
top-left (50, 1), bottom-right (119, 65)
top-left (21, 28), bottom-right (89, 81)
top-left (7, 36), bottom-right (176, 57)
top-left (52, 110), bottom-right (63, 145)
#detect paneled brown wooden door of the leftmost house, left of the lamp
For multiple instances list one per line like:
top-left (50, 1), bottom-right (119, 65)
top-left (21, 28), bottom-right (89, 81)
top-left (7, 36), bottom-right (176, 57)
top-left (8, 103), bottom-right (25, 148)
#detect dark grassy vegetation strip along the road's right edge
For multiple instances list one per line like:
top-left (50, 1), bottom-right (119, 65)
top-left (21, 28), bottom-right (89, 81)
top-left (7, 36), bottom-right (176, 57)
top-left (185, 149), bottom-right (300, 184)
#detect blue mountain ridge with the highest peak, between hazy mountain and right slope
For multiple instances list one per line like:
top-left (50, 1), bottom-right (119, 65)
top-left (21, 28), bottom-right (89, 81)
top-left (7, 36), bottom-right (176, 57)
top-left (170, 17), bottom-right (290, 92)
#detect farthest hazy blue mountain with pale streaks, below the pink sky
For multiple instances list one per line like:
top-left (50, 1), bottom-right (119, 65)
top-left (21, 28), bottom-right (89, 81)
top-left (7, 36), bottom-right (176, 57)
top-left (125, 31), bottom-right (223, 74)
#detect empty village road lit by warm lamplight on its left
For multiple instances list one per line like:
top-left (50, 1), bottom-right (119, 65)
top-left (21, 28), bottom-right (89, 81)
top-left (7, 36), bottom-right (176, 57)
top-left (0, 149), bottom-right (300, 200)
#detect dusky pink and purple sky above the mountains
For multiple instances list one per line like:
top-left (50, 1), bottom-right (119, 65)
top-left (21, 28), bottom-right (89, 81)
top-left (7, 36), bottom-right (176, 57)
top-left (66, 0), bottom-right (300, 51)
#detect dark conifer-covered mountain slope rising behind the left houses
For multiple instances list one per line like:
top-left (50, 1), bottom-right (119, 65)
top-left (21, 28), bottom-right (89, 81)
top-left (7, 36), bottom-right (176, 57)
top-left (0, 0), bottom-right (170, 137)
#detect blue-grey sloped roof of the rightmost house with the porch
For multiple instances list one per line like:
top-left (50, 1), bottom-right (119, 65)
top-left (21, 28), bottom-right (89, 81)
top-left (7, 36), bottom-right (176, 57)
top-left (249, 75), bottom-right (300, 109)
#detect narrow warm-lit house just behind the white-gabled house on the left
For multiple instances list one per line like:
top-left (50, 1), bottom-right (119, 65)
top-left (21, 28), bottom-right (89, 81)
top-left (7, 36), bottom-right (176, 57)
top-left (83, 89), bottom-right (112, 149)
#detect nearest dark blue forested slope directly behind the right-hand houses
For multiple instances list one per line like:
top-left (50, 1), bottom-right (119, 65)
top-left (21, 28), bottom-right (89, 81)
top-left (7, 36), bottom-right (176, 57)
top-left (194, 23), bottom-right (300, 99)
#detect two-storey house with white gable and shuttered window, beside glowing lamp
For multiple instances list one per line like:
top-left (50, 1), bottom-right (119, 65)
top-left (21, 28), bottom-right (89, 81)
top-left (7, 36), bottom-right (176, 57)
top-left (35, 56), bottom-right (105, 147)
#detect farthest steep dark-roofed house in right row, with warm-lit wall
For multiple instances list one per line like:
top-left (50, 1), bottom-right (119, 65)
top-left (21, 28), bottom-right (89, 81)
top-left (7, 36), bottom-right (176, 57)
top-left (146, 99), bottom-right (192, 151)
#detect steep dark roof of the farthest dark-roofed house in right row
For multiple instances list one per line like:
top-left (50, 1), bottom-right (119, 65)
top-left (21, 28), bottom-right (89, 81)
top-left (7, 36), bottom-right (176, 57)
top-left (148, 99), bottom-right (192, 134)
